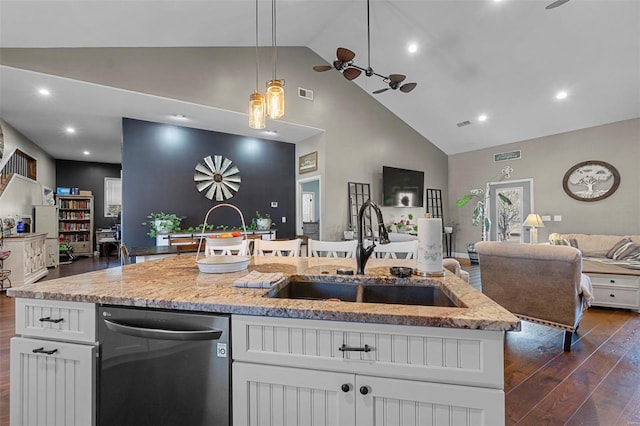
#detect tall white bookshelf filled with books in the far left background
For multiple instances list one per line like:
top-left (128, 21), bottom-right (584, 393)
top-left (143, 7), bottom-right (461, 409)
top-left (57, 195), bottom-right (94, 256)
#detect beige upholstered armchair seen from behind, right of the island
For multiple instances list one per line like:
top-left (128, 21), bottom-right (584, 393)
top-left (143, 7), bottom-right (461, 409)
top-left (475, 241), bottom-right (591, 352)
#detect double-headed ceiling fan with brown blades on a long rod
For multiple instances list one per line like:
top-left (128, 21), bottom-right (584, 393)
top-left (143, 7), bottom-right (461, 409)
top-left (313, 0), bottom-right (416, 94)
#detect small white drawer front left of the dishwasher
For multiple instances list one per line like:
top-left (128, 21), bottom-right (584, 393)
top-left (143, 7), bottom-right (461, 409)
top-left (16, 298), bottom-right (96, 343)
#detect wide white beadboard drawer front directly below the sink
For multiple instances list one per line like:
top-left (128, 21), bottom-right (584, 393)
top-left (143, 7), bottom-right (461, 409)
top-left (231, 315), bottom-right (504, 389)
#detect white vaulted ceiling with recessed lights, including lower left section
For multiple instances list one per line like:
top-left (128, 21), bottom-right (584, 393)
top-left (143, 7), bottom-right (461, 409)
top-left (0, 0), bottom-right (640, 162)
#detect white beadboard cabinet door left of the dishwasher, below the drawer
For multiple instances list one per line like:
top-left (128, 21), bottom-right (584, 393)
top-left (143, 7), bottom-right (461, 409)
top-left (10, 337), bottom-right (95, 426)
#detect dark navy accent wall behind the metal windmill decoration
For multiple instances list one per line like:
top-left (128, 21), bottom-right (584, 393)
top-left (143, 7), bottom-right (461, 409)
top-left (122, 118), bottom-right (296, 247)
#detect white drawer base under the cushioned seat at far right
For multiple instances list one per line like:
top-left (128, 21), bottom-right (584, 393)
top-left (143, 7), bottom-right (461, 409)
top-left (589, 274), bottom-right (640, 312)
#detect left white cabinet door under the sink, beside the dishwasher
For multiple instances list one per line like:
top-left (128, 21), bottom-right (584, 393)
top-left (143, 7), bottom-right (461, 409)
top-left (232, 362), bottom-right (356, 426)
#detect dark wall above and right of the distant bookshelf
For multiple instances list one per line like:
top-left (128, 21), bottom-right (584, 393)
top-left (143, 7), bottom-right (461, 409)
top-left (56, 160), bottom-right (122, 230)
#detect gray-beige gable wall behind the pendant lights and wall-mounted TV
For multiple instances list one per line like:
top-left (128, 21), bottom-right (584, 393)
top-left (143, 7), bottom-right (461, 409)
top-left (2, 47), bottom-right (448, 239)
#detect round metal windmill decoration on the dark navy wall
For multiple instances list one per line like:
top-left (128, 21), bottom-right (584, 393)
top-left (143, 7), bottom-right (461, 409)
top-left (193, 155), bottom-right (242, 201)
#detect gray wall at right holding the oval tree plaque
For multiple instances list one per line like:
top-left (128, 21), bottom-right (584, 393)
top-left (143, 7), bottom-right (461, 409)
top-left (449, 119), bottom-right (640, 252)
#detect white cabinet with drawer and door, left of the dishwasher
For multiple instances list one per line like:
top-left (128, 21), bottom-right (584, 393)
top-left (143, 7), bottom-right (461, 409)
top-left (10, 298), bottom-right (97, 426)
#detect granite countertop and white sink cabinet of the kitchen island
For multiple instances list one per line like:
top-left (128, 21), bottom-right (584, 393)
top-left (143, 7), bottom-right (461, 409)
top-left (8, 255), bottom-right (520, 425)
